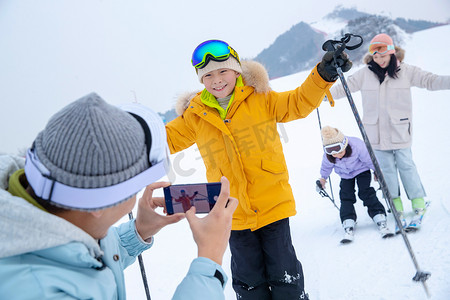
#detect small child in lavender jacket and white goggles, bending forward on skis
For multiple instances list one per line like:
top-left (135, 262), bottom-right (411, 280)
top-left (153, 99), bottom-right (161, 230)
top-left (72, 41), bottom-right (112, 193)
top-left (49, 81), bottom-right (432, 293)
top-left (320, 126), bottom-right (393, 243)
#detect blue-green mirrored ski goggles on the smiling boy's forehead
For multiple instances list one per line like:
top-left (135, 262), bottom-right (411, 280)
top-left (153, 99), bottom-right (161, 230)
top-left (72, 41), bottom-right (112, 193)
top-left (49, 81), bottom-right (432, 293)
top-left (191, 40), bottom-right (241, 69)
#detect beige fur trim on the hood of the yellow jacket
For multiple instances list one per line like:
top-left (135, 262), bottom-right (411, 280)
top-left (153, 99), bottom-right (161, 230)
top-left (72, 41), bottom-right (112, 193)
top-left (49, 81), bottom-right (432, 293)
top-left (175, 60), bottom-right (271, 115)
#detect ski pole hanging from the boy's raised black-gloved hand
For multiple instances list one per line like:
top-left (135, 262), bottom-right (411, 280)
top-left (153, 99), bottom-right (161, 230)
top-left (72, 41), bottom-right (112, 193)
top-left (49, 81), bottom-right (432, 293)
top-left (322, 33), bottom-right (431, 298)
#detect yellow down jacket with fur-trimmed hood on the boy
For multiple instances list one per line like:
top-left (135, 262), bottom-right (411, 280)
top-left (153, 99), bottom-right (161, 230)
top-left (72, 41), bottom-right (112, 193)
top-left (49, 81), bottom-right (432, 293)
top-left (166, 61), bottom-right (333, 230)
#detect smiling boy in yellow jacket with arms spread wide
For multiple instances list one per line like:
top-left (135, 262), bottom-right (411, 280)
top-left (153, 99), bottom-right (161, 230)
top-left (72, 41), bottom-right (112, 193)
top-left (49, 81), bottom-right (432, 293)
top-left (166, 40), bottom-right (351, 300)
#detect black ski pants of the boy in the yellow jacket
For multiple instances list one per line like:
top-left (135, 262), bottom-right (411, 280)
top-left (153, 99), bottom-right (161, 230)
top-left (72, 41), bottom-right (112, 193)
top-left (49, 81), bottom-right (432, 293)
top-left (230, 218), bottom-right (308, 300)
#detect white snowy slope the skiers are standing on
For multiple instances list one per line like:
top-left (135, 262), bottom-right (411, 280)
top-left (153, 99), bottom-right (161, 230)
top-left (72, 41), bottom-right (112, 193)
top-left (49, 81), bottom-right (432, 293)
top-left (126, 25), bottom-right (450, 300)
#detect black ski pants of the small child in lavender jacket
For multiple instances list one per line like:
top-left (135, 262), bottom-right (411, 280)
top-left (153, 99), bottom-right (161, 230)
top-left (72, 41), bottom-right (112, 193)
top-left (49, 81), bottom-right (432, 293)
top-left (339, 170), bottom-right (386, 222)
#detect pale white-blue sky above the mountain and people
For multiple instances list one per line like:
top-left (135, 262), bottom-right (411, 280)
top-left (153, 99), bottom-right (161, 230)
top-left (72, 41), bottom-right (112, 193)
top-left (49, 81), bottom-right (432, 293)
top-left (0, 0), bottom-right (450, 151)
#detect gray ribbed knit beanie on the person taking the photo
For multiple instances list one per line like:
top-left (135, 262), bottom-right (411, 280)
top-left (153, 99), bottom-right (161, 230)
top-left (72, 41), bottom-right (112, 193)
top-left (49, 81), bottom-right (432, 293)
top-left (34, 93), bottom-right (150, 188)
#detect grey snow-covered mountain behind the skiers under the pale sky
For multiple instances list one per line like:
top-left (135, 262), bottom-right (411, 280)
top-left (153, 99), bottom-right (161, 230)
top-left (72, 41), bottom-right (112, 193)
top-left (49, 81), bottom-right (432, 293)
top-left (254, 6), bottom-right (442, 78)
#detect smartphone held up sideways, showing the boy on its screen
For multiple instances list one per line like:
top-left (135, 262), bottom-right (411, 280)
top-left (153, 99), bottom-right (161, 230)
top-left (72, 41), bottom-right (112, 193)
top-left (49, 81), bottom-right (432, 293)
top-left (164, 182), bottom-right (222, 215)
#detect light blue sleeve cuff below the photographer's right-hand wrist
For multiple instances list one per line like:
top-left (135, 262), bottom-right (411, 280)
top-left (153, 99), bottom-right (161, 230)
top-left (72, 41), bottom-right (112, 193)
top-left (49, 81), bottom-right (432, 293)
top-left (172, 257), bottom-right (227, 300)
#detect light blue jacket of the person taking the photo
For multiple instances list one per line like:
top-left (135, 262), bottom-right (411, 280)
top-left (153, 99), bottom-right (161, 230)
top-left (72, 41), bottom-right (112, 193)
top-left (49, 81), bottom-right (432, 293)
top-left (0, 155), bottom-right (227, 300)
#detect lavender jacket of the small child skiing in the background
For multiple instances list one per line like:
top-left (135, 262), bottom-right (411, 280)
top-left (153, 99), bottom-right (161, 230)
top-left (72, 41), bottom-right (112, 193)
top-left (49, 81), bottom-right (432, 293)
top-left (320, 136), bottom-right (374, 179)
